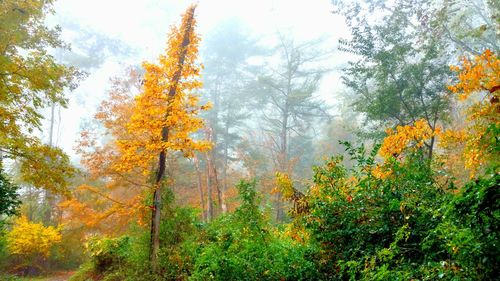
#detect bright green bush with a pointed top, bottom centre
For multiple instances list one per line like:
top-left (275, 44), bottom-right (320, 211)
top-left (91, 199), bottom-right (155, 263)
top-left (189, 181), bottom-right (316, 280)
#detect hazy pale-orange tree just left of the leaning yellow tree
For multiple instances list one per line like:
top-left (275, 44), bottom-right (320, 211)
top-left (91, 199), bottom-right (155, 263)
top-left (59, 68), bottom-right (150, 233)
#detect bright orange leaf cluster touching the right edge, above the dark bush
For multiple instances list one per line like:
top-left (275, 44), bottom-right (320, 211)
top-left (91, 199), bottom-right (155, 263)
top-left (443, 50), bottom-right (500, 177)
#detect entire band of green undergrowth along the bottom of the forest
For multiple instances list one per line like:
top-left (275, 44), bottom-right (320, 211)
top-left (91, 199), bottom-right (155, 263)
top-left (74, 146), bottom-right (500, 281)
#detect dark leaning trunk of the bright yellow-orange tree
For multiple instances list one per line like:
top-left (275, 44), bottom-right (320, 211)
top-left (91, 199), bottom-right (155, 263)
top-left (150, 6), bottom-right (196, 272)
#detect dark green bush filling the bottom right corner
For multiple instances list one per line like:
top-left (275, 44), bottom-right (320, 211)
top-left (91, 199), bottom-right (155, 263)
top-left (430, 174), bottom-right (500, 280)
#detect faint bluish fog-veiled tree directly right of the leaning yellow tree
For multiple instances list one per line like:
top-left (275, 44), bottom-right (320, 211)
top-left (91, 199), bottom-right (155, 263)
top-left (202, 19), bottom-right (263, 212)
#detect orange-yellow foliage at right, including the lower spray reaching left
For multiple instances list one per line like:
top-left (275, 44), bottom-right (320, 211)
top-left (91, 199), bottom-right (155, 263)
top-left (373, 50), bottom-right (500, 178)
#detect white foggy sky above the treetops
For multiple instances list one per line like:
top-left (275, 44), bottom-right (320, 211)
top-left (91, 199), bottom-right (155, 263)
top-left (44, 0), bottom-right (356, 159)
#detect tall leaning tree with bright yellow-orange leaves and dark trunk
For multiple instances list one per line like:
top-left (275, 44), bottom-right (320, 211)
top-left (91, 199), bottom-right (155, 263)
top-left (118, 5), bottom-right (210, 269)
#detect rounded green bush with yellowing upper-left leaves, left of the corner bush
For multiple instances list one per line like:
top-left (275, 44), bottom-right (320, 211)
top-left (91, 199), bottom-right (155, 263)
top-left (303, 143), bottom-right (444, 279)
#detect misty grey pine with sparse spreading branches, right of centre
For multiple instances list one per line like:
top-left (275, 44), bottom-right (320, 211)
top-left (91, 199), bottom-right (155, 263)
top-left (259, 37), bottom-right (328, 221)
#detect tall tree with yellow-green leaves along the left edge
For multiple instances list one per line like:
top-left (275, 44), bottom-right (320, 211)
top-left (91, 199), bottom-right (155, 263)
top-left (0, 0), bottom-right (80, 192)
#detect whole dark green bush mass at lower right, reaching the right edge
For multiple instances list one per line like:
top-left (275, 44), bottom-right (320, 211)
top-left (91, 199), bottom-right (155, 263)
top-left (300, 143), bottom-right (500, 280)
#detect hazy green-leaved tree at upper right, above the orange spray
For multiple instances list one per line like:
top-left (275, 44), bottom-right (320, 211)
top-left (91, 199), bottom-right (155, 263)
top-left (334, 0), bottom-right (451, 157)
